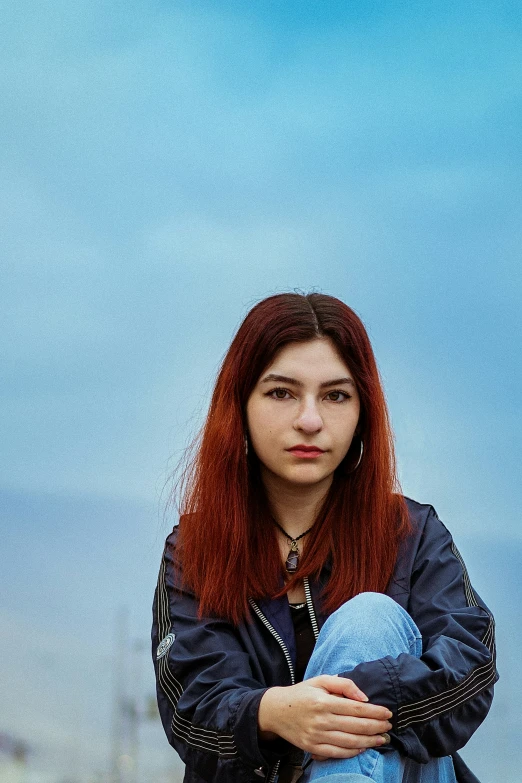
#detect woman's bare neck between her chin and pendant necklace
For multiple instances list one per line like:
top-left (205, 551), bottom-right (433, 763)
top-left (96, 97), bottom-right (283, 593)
top-left (262, 469), bottom-right (332, 538)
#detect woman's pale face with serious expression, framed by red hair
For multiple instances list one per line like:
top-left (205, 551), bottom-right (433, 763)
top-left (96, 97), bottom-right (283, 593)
top-left (246, 337), bottom-right (360, 496)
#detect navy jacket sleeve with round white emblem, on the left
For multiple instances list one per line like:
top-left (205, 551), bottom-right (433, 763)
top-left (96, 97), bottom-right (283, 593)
top-left (152, 532), bottom-right (281, 783)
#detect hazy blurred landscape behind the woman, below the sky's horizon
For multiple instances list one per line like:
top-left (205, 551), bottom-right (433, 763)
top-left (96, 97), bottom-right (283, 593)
top-left (0, 491), bottom-right (522, 783)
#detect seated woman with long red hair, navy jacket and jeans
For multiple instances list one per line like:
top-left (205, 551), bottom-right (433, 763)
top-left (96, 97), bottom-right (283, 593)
top-left (152, 293), bottom-right (497, 783)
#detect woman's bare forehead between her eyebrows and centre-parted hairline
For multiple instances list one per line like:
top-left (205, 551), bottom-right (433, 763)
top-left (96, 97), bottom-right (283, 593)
top-left (261, 337), bottom-right (351, 382)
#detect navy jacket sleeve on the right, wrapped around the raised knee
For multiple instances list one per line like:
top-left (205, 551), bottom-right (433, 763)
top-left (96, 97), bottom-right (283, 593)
top-left (344, 507), bottom-right (498, 763)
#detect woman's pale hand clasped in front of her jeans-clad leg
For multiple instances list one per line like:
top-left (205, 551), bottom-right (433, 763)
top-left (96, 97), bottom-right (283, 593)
top-left (258, 674), bottom-right (392, 760)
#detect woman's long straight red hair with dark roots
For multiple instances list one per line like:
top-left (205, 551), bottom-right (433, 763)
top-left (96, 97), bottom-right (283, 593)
top-left (173, 293), bottom-right (409, 623)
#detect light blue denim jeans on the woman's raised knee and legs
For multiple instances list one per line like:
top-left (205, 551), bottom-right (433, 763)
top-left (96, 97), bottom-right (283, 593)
top-left (300, 593), bottom-right (456, 783)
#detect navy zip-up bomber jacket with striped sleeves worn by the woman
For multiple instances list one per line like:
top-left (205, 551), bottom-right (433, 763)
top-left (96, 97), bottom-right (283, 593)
top-left (152, 498), bottom-right (498, 783)
